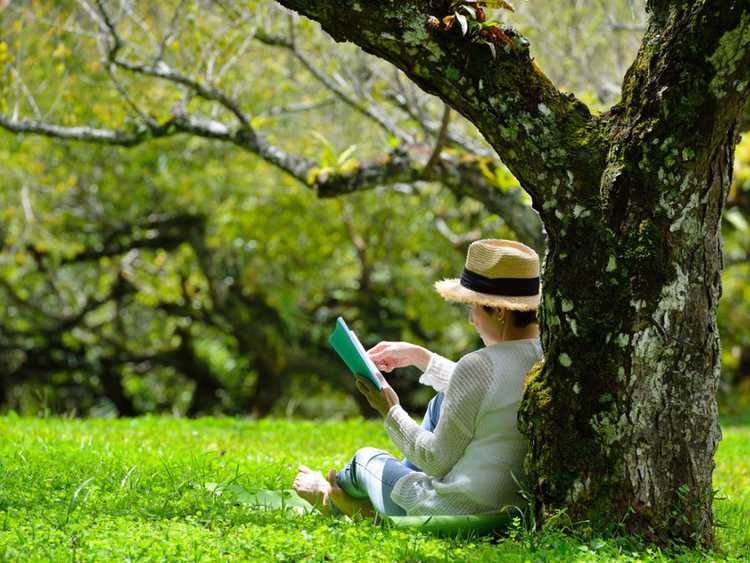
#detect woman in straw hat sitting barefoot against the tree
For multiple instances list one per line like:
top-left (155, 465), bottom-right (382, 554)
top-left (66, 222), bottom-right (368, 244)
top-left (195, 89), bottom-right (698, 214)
top-left (294, 239), bottom-right (542, 516)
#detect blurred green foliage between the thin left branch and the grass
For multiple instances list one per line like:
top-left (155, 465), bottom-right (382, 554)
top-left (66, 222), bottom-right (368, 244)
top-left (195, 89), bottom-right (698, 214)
top-left (0, 130), bottom-right (496, 414)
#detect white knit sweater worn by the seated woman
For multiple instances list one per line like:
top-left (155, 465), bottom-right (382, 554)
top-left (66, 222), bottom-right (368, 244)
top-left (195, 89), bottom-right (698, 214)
top-left (385, 338), bottom-right (542, 516)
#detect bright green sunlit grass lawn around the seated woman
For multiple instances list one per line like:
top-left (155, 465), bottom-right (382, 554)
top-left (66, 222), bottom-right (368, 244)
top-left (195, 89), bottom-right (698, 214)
top-left (0, 416), bottom-right (750, 561)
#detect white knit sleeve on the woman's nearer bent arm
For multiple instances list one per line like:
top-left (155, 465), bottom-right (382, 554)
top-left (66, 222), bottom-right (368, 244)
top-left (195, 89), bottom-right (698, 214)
top-left (385, 352), bottom-right (493, 477)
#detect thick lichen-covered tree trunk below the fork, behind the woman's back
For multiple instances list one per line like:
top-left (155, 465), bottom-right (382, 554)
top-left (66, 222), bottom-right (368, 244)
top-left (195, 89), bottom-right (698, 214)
top-left (521, 126), bottom-right (733, 543)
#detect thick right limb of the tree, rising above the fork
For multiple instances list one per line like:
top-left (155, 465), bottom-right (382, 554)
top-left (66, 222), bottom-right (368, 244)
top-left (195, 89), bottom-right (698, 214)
top-left (599, 0), bottom-right (750, 230)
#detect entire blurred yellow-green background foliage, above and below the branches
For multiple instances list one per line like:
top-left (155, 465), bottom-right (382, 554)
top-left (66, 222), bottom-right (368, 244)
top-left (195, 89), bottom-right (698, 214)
top-left (0, 0), bottom-right (750, 416)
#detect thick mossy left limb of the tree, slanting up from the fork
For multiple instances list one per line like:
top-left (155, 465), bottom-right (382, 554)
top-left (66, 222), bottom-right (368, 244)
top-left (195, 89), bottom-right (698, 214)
top-left (280, 0), bottom-right (606, 206)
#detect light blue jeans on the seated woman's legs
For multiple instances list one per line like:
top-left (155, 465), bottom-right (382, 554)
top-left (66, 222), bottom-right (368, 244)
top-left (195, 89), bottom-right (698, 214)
top-left (336, 392), bottom-right (444, 516)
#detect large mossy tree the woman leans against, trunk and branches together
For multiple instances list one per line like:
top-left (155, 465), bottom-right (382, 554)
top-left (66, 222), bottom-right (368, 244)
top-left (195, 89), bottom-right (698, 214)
top-left (0, 0), bottom-right (750, 544)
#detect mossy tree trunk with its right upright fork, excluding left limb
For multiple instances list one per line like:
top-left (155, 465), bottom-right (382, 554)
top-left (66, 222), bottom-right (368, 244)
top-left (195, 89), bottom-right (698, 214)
top-left (520, 3), bottom-right (750, 544)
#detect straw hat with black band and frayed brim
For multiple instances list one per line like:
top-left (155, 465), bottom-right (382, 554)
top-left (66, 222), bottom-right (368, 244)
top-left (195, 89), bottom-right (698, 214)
top-left (435, 239), bottom-right (541, 311)
